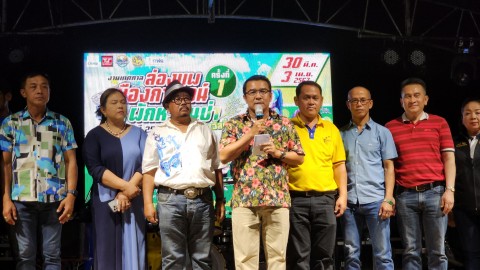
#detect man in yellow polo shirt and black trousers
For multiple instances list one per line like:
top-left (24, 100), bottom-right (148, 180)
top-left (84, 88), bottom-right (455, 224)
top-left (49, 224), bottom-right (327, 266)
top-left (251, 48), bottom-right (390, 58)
top-left (287, 81), bottom-right (347, 269)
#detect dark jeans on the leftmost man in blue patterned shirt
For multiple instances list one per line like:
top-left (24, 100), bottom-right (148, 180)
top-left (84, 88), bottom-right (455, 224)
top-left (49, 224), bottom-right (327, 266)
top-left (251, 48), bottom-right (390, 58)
top-left (14, 201), bottom-right (62, 270)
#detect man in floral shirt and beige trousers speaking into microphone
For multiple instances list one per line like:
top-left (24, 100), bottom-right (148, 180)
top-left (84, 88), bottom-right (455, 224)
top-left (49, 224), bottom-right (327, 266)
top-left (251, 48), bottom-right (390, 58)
top-left (220, 75), bottom-right (304, 270)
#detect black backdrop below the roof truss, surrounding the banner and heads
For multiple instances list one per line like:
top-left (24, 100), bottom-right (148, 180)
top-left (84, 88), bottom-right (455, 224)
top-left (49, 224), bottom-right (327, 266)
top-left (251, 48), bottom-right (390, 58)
top-left (0, 18), bottom-right (480, 196)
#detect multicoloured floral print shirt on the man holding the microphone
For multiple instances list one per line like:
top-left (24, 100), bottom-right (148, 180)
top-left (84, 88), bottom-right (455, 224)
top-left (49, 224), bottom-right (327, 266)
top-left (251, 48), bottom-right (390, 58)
top-left (220, 110), bottom-right (304, 208)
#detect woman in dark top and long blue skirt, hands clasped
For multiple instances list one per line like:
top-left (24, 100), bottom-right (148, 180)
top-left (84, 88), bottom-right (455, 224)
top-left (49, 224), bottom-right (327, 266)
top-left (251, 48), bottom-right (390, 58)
top-left (83, 88), bottom-right (147, 270)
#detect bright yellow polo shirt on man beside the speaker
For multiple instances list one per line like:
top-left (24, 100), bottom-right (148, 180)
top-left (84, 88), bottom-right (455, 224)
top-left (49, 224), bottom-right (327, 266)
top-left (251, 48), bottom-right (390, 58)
top-left (288, 115), bottom-right (346, 192)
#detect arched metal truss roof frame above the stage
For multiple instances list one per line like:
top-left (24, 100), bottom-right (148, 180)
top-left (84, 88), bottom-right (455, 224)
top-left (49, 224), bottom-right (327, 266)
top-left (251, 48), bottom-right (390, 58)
top-left (0, 0), bottom-right (480, 51)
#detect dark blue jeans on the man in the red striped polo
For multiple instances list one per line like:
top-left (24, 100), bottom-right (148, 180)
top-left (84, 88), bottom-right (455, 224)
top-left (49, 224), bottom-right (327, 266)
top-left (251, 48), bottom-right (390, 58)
top-left (396, 186), bottom-right (448, 270)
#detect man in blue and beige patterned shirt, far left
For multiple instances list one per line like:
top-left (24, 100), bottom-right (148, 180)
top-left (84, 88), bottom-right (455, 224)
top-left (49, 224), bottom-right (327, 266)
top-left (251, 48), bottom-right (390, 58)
top-left (0, 73), bottom-right (77, 269)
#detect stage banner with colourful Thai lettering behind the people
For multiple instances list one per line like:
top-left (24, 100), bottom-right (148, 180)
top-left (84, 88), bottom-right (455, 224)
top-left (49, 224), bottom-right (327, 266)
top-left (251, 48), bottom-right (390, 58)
top-left (84, 52), bottom-right (333, 199)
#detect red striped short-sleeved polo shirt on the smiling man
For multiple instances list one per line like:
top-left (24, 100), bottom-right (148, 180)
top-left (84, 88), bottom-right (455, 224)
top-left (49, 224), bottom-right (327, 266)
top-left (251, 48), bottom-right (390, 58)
top-left (385, 112), bottom-right (455, 188)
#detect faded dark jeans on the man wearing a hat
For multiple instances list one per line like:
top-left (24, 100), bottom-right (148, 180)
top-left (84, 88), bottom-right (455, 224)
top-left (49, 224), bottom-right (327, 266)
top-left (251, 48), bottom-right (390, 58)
top-left (157, 190), bottom-right (215, 270)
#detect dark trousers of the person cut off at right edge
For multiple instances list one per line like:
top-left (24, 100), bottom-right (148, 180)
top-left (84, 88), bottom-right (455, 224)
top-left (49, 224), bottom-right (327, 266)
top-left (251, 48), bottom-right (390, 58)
top-left (453, 208), bottom-right (480, 270)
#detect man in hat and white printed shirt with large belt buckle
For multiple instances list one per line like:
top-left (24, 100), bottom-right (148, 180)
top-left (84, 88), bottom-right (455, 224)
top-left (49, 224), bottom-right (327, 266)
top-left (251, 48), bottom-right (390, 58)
top-left (142, 81), bottom-right (225, 269)
